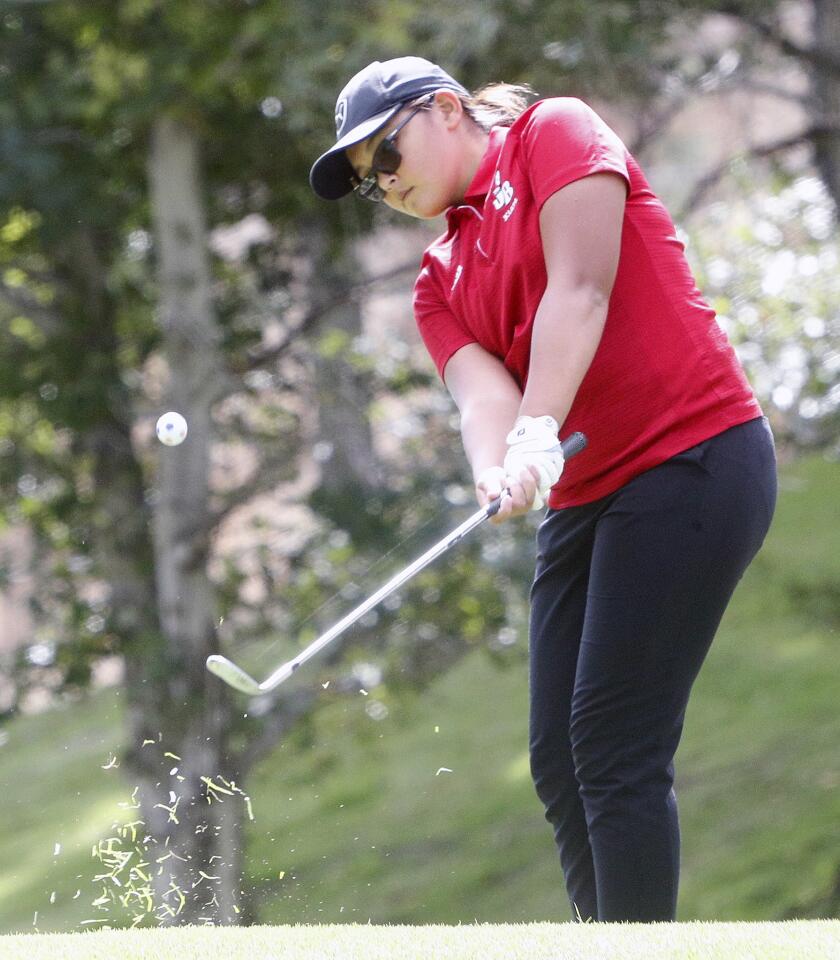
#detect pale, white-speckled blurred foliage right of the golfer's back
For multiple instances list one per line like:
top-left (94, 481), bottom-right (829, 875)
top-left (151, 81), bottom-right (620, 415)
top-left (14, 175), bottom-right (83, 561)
top-left (689, 174), bottom-right (840, 446)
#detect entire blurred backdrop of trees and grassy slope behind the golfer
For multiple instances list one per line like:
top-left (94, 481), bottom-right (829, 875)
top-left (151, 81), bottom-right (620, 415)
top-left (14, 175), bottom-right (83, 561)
top-left (0, 0), bottom-right (840, 931)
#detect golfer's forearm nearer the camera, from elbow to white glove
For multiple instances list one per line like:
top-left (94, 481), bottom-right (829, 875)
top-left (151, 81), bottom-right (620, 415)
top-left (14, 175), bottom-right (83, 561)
top-left (517, 286), bottom-right (609, 424)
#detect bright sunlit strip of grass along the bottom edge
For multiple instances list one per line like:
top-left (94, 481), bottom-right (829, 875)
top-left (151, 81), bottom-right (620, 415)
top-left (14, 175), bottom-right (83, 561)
top-left (0, 921), bottom-right (840, 960)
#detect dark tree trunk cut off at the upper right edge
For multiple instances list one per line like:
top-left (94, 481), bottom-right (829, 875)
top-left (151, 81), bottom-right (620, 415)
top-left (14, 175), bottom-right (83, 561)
top-left (811, 0), bottom-right (840, 211)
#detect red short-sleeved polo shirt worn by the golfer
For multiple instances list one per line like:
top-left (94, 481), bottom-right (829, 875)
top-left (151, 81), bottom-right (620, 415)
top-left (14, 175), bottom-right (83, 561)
top-left (414, 97), bottom-right (761, 509)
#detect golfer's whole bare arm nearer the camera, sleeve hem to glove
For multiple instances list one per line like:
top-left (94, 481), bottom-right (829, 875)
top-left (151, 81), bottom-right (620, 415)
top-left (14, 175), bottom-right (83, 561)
top-left (517, 173), bottom-right (626, 424)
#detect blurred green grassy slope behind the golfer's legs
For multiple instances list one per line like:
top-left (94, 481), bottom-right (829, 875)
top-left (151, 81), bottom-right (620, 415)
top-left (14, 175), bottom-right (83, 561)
top-left (0, 459), bottom-right (840, 932)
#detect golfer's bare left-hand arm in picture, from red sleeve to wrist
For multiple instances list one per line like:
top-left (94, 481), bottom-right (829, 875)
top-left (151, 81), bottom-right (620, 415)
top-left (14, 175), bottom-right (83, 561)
top-left (443, 343), bottom-right (522, 478)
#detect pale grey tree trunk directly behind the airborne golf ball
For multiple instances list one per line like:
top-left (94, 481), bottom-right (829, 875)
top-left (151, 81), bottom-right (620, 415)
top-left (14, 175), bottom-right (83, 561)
top-left (139, 119), bottom-right (244, 923)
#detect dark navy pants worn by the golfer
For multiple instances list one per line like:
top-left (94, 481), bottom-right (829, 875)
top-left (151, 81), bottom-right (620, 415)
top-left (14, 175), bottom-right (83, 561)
top-left (530, 418), bottom-right (776, 921)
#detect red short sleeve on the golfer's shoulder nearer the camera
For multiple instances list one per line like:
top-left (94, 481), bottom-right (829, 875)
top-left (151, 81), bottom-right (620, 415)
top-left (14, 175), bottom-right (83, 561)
top-left (520, 97), bottom-right (630, 207)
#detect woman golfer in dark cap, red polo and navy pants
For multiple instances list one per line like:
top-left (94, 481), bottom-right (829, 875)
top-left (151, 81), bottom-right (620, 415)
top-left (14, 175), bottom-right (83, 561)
top-left (310, 57), bottom-right (776, 921)
